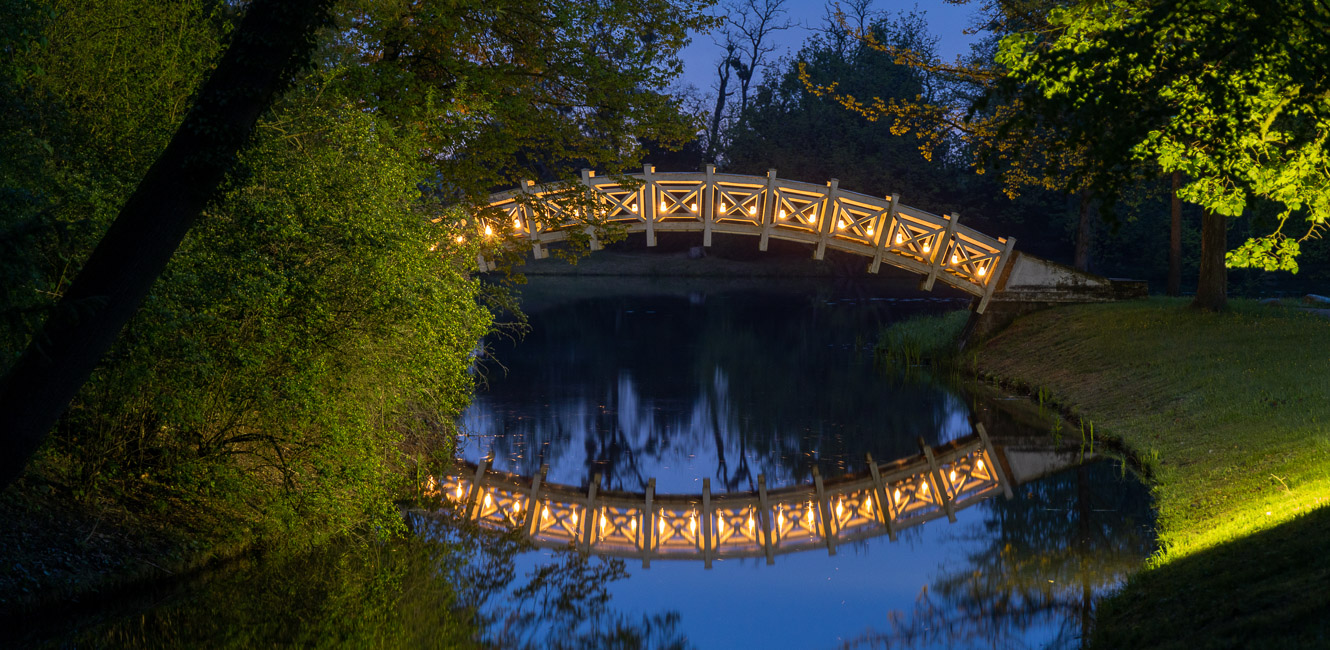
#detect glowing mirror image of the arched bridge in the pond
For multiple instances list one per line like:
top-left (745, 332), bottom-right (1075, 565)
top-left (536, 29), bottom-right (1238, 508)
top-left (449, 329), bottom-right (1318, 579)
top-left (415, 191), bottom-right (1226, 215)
top-left (428, 424), bottom-right (1012, 568)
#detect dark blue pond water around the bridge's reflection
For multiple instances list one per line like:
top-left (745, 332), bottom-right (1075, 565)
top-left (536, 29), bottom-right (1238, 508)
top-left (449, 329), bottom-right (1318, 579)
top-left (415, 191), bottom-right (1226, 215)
top-left (29, 278), bottom-right (1153, 649)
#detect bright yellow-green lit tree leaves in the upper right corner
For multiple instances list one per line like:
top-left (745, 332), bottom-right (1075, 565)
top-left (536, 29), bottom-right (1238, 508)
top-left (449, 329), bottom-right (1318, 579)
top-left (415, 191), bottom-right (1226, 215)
top-left (998, 0), bottom-right (1330, 271)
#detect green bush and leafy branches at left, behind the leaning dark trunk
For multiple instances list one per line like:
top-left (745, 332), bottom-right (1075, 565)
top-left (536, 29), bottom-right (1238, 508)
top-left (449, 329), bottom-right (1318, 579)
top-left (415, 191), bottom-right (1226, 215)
top-left (0, 0), bottom-right (709, 552)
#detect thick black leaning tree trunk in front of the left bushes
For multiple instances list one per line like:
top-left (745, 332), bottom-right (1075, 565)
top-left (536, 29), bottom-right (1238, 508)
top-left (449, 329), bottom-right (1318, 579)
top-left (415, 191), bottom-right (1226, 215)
top-left (0, 0), bottom-right (333, 489)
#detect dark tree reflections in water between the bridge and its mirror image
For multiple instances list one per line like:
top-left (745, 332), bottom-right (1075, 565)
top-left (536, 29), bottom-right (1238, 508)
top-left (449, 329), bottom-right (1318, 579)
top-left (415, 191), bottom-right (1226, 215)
top-left (464, 295), bottom-right (966, 492)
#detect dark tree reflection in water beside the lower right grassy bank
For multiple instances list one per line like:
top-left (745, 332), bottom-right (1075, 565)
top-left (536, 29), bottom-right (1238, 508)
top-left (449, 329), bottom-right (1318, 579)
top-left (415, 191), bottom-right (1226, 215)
top-left (845, 463), bottom-right (1153, 647)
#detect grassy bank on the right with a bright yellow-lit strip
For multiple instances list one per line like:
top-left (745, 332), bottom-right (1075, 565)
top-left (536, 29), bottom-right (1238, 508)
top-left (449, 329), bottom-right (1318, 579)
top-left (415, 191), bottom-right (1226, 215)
top-left (979, 299), bottom-right (1330, 647)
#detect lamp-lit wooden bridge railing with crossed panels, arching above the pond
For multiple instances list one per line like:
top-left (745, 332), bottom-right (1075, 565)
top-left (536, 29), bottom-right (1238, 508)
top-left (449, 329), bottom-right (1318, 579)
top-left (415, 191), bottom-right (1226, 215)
top-left (477, 165), bottom-right (1016, 312)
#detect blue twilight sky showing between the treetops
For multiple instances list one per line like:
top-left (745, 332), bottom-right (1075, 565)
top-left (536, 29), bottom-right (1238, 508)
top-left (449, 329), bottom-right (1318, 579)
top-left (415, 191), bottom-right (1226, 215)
top-left (680, 0), bottom-right (978, 93)
